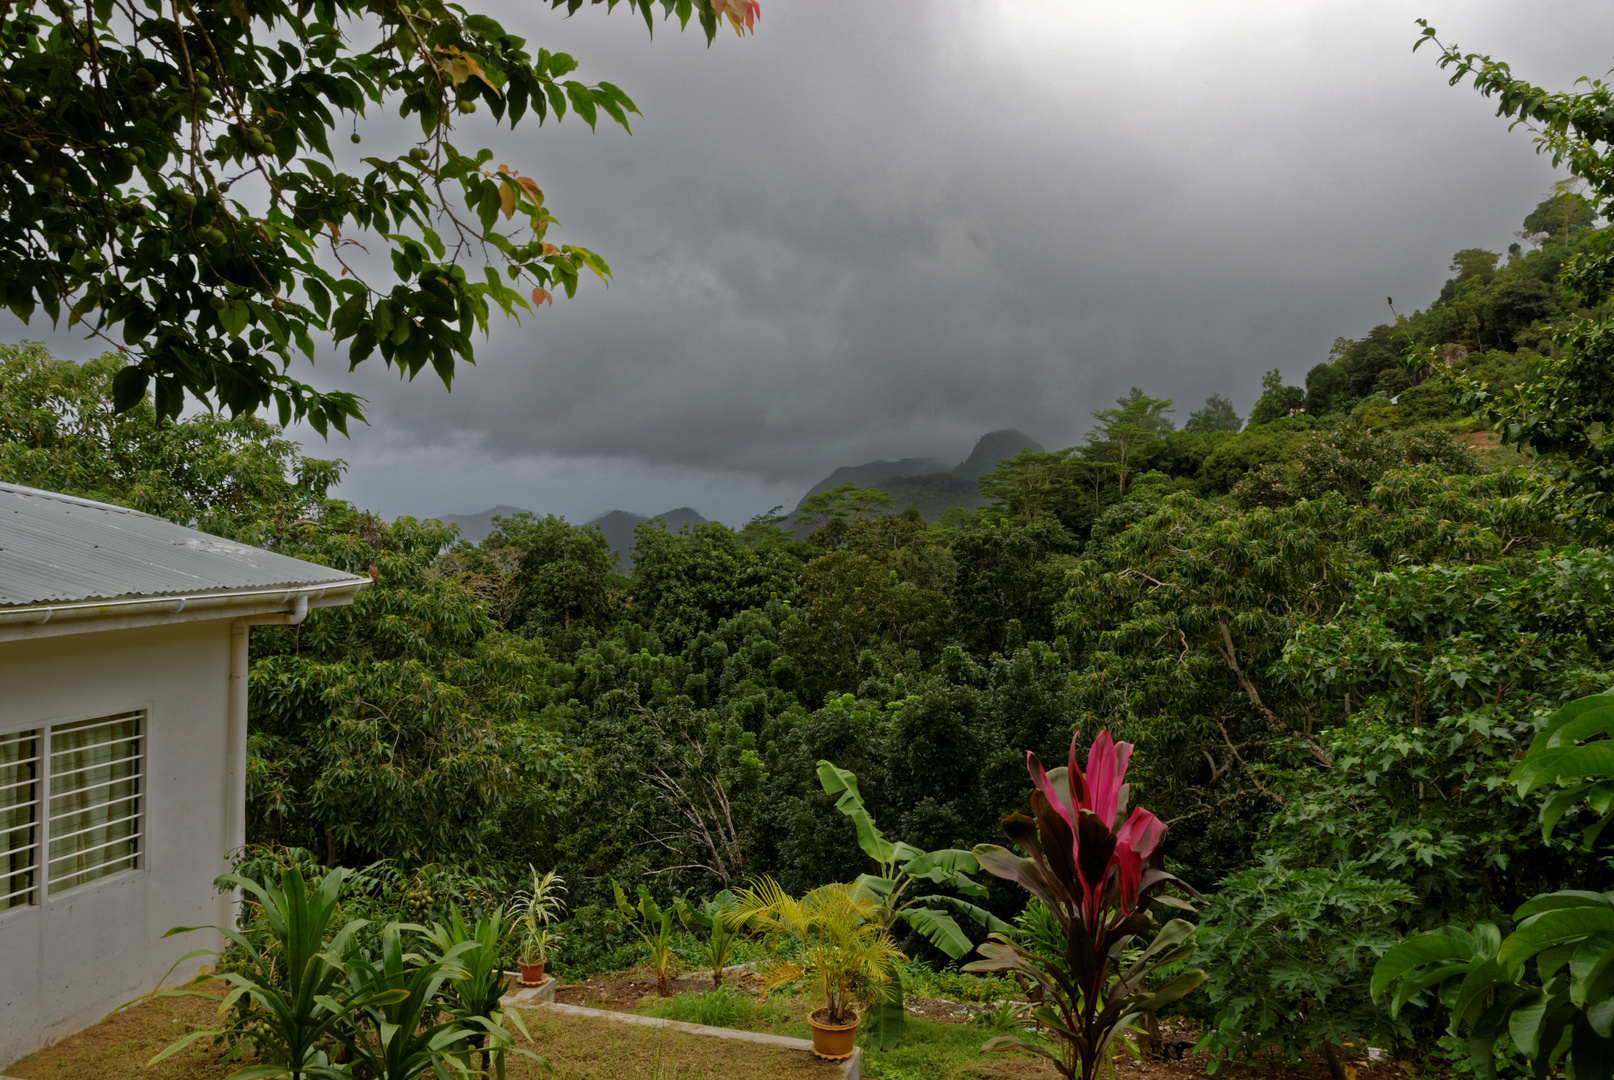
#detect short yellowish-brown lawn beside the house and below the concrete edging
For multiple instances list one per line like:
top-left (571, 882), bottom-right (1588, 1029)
top-left (3, 998), bottom-right (839, 1080)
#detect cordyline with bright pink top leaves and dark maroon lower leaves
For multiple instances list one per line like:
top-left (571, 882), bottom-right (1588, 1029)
top-left (964, 731), bottom-right (1206, 1080)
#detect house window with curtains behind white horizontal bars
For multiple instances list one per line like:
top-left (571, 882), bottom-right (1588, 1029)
top-left (0, 712), bottom-right (145, 910)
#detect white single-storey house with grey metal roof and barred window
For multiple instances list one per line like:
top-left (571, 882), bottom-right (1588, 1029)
top-left (0, 483), bottom-right (370, 1070)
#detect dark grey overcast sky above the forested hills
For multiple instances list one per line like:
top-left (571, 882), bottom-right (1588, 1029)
top-left (13, 0), bottom-right (1614, 523)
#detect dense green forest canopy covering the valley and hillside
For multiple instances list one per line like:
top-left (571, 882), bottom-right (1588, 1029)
top-left (0, 176), bottom-right (1614, 1043)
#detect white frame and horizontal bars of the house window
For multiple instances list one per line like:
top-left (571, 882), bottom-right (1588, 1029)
top-left (0, 705), bottom-right (152, 919)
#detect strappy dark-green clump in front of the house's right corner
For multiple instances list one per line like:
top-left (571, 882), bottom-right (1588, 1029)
top-left (147, 865), bottom-right (408, 1080)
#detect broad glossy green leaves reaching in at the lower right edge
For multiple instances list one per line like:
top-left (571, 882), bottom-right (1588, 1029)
top-left (1370, 694), bottom-right (1614, 1080)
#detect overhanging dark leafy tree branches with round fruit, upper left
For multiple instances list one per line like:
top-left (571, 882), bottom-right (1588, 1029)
top-left (0, 0), bottom-right (757, 431)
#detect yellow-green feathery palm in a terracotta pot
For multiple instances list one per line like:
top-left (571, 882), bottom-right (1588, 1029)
top-left (723, 878), bottom-right (904, 1061)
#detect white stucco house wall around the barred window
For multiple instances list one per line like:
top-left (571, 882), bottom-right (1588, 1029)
top-left (0, 620), bottom-right (231, 1072)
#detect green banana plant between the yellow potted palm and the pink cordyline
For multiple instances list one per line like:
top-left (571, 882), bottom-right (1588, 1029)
top-left (818, 760), bottom-right (1014, 1049)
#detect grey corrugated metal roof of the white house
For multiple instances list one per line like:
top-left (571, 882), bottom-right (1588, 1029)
top-left (0, 483), bottom-right (363, 610)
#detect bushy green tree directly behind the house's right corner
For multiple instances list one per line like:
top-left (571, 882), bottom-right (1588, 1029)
top-left (247, 504), bottom-right (560, 865)
